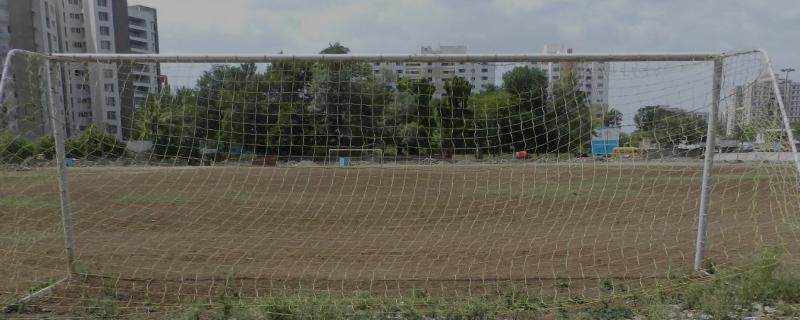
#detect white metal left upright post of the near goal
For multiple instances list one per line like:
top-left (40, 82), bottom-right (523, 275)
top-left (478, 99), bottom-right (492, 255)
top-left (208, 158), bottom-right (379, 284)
top-left (45, 58), bottom-right (75, 275)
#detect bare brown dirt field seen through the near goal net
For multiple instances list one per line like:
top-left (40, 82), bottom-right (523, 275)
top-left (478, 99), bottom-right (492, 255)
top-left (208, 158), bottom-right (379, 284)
top-left (0, 162), bottom-right (800, 312)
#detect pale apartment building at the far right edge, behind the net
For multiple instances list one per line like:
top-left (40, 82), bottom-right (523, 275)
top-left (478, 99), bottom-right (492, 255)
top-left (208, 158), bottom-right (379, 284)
top-left (721, 75), bottom-right (800, 135)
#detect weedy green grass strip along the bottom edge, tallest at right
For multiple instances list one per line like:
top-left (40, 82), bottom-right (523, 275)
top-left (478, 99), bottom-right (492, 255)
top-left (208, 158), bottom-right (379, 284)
top-left (166, 248), bottom-right (800, 320)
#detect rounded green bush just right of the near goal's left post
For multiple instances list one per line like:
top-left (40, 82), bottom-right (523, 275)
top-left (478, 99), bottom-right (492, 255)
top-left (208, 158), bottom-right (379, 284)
top-left (66, 126), bottom-right (125, 160)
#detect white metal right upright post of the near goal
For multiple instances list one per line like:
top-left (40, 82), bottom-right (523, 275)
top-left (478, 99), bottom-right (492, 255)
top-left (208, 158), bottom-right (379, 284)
top-left (694, 59), bottom-right (722, 271)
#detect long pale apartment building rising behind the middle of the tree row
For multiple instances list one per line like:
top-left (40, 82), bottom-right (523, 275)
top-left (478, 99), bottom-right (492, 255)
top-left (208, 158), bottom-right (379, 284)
top-left (372, 45), bottom-right (497, 97)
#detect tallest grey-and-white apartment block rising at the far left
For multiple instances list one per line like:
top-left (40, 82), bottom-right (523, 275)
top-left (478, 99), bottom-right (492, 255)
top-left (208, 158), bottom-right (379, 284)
top-left (0, 0), bottom-right (159, 138)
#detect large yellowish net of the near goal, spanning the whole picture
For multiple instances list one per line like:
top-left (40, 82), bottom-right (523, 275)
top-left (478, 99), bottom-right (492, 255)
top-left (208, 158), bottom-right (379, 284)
top-left (0, 51), bottom-right (800, 317)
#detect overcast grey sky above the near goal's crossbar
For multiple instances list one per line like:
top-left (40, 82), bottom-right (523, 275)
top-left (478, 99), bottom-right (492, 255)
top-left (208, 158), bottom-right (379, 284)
top-left (128, 0), bottom-right (800, 127)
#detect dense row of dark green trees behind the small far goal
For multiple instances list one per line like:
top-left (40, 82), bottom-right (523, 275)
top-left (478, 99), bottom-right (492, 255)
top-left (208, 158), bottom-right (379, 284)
top-left (131, 43), bottom-right (592, 156)
